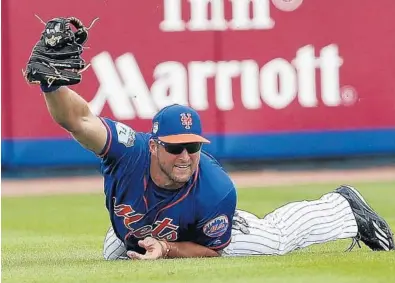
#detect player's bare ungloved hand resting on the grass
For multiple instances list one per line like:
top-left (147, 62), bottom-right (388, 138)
top-left (127, 237), bottom-right (166, 260)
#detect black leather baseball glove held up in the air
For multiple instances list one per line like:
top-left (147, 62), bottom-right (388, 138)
top-left (23, 17), bottom-right (97, 87)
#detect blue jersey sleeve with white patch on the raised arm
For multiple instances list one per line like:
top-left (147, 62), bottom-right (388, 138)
top-left (99, 118), bottom-right (149, 170)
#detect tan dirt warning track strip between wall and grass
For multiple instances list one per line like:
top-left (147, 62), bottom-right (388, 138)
top-left (1, 166), bottom-right (395, 196)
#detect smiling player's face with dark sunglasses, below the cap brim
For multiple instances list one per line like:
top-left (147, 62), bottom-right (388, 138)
top-left (153, 142), bottom-right (202, 183)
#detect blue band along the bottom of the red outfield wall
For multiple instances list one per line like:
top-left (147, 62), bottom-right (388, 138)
top-left (1, 128), bottom-right (395, 169)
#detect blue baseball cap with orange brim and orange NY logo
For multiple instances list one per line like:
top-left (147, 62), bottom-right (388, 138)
top-left (151, 104), bottom-right (210, 143)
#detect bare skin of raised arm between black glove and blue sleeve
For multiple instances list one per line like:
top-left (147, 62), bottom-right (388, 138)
top-left (45, 86), bottom-right (107, 154)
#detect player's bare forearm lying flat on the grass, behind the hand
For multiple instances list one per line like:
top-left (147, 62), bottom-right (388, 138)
top-left (165, 242), bottom-right (220, 258)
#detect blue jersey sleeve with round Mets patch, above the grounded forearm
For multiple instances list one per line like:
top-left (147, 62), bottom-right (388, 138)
top-left (196, 190), bottom-right (237, 250)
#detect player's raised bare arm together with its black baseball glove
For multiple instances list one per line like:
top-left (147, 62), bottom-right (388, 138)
top-left (24, 17), bottom-right (107, 154)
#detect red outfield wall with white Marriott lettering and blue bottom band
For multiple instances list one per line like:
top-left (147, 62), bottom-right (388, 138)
top-left (1, 0), bottom-right (395, 183)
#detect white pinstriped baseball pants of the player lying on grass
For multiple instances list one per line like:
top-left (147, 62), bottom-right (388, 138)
top-left (103, 193), bottom-right (358, 260)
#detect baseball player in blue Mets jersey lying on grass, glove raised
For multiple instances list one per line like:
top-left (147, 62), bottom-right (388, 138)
top-left (24, 18), bottom-right (394, 260)
